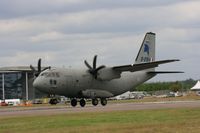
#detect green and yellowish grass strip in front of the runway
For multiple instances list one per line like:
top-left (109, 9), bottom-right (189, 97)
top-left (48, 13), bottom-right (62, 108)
top-left (0, 108), bottom-right (200, 133)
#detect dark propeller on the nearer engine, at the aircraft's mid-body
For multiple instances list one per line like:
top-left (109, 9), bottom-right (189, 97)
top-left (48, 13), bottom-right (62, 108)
top-left (84, 55), bottom-right (105, 79)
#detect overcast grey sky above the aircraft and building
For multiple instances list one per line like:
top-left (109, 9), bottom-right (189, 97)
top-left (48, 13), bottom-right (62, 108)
top-left (0, 0), bottom-right (200, 81)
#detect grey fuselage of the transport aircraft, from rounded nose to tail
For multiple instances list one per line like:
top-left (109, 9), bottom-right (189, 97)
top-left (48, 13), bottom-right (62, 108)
top-left (33, 68), bottom-right (155, 98)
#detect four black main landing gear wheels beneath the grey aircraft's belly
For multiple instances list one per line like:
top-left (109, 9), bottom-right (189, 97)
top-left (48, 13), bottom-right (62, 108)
top-left (71, 98), bottom-right (107, 107)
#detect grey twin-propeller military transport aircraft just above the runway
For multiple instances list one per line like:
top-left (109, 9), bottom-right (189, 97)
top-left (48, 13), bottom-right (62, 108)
top-left (30, 32), bottom-right (181, 107)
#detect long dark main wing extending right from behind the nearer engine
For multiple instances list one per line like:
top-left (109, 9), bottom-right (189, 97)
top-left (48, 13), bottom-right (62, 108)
top-left (112, 59), bottom-right (180, 72)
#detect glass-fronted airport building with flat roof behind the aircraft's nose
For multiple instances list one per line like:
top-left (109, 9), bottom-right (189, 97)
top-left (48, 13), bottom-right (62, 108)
top-left (0, 66), bottom-right (45, 100)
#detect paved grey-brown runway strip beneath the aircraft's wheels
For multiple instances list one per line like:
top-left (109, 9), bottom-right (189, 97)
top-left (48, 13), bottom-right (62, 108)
top-left (0, 101), bottom-right (200, 117)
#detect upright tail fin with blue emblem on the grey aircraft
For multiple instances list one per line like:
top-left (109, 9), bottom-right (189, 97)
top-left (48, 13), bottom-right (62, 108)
top-left (135, 32), bottom-right (156, 64)
